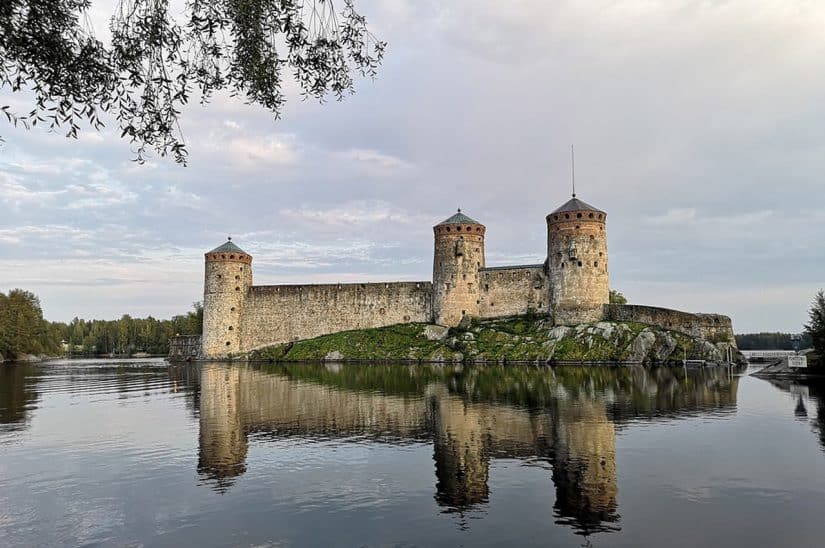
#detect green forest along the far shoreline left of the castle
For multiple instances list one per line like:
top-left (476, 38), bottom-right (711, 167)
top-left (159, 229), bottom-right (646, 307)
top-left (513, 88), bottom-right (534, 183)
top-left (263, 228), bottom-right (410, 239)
top-left (0, 289), bottom-right (203, 361)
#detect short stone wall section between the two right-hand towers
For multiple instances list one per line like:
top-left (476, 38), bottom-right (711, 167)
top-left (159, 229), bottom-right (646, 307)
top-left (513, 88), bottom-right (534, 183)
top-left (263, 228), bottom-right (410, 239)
top-left (478, 264), bottom-right (550, 318)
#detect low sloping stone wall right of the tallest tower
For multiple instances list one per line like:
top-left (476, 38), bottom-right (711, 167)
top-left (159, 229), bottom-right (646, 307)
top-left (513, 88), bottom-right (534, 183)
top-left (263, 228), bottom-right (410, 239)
top-left (605, 304), bottom-right (736, 346)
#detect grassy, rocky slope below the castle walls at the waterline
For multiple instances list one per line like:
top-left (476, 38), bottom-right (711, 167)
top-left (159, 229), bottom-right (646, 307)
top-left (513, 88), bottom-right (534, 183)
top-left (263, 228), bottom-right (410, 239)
top-left (246, 316), bottom-right (723, 363)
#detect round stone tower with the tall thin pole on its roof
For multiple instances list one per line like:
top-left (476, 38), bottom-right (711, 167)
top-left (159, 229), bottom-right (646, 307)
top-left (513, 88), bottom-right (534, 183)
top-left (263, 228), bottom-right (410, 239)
top-left (547, 194), bottom-right (610, 325)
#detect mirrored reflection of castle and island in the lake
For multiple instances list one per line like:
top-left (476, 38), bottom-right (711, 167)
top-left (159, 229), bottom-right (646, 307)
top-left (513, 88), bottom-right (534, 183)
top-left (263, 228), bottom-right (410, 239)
top-left (171, 364), bottom-right (738, 533)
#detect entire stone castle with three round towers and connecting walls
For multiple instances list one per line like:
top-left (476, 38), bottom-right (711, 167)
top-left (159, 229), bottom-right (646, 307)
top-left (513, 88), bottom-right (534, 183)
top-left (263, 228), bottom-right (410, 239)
top-left (200, 194), bottom-right (732, 359)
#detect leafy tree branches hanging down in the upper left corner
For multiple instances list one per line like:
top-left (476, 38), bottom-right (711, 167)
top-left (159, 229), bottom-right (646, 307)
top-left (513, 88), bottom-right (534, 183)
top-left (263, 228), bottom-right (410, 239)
top-left (0, 0), bottom-right (386, 164)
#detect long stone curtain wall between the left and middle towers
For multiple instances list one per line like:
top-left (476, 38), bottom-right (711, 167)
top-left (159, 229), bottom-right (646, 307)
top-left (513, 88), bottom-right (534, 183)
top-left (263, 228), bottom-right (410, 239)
top-left (241, 282), bottom-right (432, 351)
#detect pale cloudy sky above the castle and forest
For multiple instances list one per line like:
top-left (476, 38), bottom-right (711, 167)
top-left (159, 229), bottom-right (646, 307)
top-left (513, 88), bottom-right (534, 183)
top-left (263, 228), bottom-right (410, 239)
top-left (0, 0), bottom-right (825, 332)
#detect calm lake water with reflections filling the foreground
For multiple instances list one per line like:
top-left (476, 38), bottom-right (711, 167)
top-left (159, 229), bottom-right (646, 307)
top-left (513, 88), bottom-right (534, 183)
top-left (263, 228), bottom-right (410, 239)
top-left (0, 360), bottom-right (825, 547)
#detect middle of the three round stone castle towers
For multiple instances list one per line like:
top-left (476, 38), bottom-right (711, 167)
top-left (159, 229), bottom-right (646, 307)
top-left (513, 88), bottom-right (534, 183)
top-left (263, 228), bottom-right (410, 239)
top-left (433, 209), bottom-right (486, 326)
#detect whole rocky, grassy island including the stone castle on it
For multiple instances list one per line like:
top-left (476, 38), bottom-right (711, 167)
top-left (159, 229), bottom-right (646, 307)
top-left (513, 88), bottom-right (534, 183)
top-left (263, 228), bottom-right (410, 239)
top-left (170, 194), bottom-right (744, 364)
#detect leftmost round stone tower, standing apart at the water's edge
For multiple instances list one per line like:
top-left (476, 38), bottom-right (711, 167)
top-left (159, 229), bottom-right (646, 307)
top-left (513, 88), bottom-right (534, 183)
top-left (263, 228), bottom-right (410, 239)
top-left (202, 238), bottom-right (252, 358)
